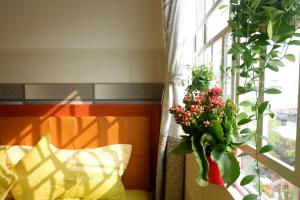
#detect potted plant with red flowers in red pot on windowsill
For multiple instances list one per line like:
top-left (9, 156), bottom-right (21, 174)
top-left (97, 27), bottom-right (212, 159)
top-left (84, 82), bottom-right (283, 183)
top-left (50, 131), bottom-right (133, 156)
top-left (169, 66), bottom-right (248, 187)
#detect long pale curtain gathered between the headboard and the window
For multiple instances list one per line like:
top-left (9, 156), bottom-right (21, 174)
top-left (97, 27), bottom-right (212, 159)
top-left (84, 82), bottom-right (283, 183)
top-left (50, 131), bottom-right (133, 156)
top-left (156, 0), bottom-right (196, 200)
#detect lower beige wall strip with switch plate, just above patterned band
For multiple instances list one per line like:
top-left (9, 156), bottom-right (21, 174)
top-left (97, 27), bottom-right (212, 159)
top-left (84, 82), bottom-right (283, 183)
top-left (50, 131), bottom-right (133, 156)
top-left (0, 49), bottom-right (164, 83)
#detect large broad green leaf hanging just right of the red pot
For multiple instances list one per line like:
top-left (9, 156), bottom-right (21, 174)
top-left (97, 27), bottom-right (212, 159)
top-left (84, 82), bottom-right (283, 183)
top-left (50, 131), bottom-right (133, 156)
top-left (211, 150), bottom-right (240, 187)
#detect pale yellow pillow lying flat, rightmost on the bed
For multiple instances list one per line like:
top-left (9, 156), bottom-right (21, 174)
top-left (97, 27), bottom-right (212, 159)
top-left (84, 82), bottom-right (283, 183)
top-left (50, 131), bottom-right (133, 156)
top-left (60, 144), bottom-right (132, 200)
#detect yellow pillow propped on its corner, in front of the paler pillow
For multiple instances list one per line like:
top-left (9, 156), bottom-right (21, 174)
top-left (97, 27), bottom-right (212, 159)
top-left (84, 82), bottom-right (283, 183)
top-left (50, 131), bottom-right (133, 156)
top-left (12, 134), bottom-right (76, 200)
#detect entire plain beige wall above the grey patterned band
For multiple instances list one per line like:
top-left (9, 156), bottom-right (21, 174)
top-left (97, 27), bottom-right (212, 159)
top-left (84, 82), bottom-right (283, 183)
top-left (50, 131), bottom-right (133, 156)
top-left (0, 0), bottom-right (165, 83)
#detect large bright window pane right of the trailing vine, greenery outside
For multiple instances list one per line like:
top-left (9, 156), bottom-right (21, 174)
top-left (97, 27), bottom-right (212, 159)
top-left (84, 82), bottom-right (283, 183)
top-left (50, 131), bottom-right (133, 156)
top-left (263, 46), bottom-right (300, 167)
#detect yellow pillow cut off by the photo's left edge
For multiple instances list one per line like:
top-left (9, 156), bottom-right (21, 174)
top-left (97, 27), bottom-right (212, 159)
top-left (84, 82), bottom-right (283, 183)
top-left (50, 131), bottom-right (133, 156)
top-left (0, 149), bottom-right (17, 200)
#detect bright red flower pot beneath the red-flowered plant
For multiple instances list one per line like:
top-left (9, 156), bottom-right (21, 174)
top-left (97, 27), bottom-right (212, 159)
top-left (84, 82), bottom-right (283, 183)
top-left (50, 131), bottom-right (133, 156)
top-left (207, 156), bottom-right (224, 186)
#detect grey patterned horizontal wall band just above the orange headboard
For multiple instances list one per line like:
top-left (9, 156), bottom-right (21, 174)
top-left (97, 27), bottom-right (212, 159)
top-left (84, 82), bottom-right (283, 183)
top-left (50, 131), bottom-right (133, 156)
top-left (0, 83), bottom-right (164, 104)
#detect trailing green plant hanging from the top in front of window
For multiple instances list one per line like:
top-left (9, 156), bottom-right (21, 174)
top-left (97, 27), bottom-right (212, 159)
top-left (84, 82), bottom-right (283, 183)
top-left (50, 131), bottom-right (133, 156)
top-left (227, 0), bottom-right (300, 200)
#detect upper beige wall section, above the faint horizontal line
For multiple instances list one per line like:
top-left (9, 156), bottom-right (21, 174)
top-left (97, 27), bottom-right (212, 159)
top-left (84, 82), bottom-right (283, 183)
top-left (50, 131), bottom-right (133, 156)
top-left (0, 0), bottom-right (162, 48)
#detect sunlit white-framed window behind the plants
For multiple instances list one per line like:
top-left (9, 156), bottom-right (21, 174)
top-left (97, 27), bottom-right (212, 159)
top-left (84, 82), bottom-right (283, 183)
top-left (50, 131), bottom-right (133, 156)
top-left (194, 0), bottom-right (300, 197)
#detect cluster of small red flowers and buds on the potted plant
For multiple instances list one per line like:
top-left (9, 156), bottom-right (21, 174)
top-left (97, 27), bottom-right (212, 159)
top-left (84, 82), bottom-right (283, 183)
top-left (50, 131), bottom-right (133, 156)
top-left (169, 88), bottom-right (224, 127)
